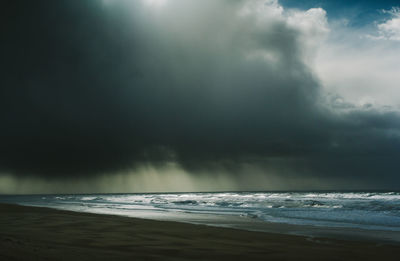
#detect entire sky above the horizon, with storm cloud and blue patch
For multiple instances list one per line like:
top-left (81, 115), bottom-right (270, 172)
top-left (0, 0), bottom-right (400, 194)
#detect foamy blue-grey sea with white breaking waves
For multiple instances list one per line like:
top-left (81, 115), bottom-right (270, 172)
top-left (0, 192), bottom-right (400, 231)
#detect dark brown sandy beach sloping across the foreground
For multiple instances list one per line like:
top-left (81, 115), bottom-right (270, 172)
top-left (0, 204), bottom-right (400, 260)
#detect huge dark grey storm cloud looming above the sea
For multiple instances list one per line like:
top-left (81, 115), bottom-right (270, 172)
top-left (0, 1), bottom-right (400, 185)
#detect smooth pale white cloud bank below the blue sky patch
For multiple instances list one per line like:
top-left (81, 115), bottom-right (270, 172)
top-left (314, 8), bottom-right (400, 108)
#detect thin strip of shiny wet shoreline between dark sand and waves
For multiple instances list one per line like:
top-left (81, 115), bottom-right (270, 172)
top-left (12, 203), bottom-right (400, 245)
